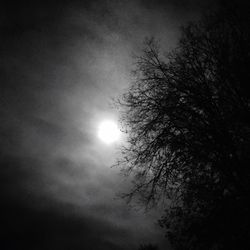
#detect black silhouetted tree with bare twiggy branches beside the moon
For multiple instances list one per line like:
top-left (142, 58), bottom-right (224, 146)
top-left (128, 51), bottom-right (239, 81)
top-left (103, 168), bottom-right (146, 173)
top-left (117, 1), bottom-right (250, 249)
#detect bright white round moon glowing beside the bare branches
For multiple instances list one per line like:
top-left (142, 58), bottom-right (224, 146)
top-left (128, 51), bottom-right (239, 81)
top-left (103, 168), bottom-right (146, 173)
top-left (98, 120), bottom-right (120, 144)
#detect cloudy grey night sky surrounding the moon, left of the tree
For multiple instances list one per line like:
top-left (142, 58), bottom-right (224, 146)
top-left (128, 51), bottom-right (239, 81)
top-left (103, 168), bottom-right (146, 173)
top-left (0, 0), bottom-right (215, 250)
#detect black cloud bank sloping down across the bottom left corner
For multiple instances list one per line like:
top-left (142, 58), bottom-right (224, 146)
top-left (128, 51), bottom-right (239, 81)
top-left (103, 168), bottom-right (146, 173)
top-left (1, 197), bottom-right (127, 250)
